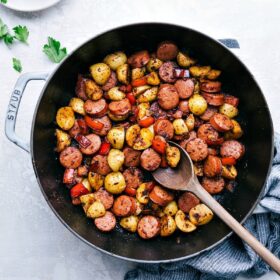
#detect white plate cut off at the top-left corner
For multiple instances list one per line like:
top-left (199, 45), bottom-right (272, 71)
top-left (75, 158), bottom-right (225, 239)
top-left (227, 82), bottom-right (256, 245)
top-left (2, 0), bottom-right (61, 12)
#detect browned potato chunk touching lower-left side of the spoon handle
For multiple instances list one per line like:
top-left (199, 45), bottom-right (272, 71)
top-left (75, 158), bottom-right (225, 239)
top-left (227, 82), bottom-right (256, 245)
top-left (189, 203), bottom-right (213, 226)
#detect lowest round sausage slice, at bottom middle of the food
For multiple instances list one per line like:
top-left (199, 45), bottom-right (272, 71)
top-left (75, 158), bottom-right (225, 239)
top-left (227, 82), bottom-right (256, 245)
top-left (137, 215), bottom-right (160, 239)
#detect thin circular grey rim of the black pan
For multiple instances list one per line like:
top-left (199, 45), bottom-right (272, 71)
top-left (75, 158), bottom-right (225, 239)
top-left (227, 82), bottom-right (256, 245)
top-left (30, 21), bottom-right (274, 264)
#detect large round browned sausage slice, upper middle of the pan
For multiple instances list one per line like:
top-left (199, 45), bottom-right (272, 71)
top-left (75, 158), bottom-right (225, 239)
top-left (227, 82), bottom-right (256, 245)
top-left (158, 84), bottom-right (179, 110)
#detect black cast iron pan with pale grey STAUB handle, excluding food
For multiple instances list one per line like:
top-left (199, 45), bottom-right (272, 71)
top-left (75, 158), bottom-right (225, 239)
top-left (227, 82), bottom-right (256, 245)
top-left (6, 23), bottom-right (273, 262)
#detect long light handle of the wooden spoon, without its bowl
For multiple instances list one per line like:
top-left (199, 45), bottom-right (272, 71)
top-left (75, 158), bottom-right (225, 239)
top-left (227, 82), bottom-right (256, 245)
top-left (191, 180), bottom-right (280, 275)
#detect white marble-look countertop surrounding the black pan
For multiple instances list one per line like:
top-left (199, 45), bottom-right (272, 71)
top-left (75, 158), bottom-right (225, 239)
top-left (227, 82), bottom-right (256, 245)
top-left (0, 0), bottom-right (280, 280)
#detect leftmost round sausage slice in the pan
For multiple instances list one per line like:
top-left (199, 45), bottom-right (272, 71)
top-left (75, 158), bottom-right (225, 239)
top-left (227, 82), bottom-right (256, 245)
top-left (59, 147), bottom-right (83, 169)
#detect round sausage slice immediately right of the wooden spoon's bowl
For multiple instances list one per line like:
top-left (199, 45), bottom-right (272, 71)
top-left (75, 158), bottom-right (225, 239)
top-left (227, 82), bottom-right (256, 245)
top-left (186, 138), bottom-right (208, 161)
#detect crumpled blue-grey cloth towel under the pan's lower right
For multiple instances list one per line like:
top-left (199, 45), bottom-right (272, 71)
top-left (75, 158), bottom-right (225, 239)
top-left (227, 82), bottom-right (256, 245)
top-left (125, 134), bottom-right (280, 280)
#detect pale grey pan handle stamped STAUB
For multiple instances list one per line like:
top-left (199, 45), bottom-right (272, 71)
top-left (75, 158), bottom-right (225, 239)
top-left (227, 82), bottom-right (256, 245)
top-left (5, 72), bottom-right (49, 152)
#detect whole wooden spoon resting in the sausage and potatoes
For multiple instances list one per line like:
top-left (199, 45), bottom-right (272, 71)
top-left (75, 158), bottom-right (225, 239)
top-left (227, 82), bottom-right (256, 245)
top-left (152, 141), bottom-right (280, 275)
